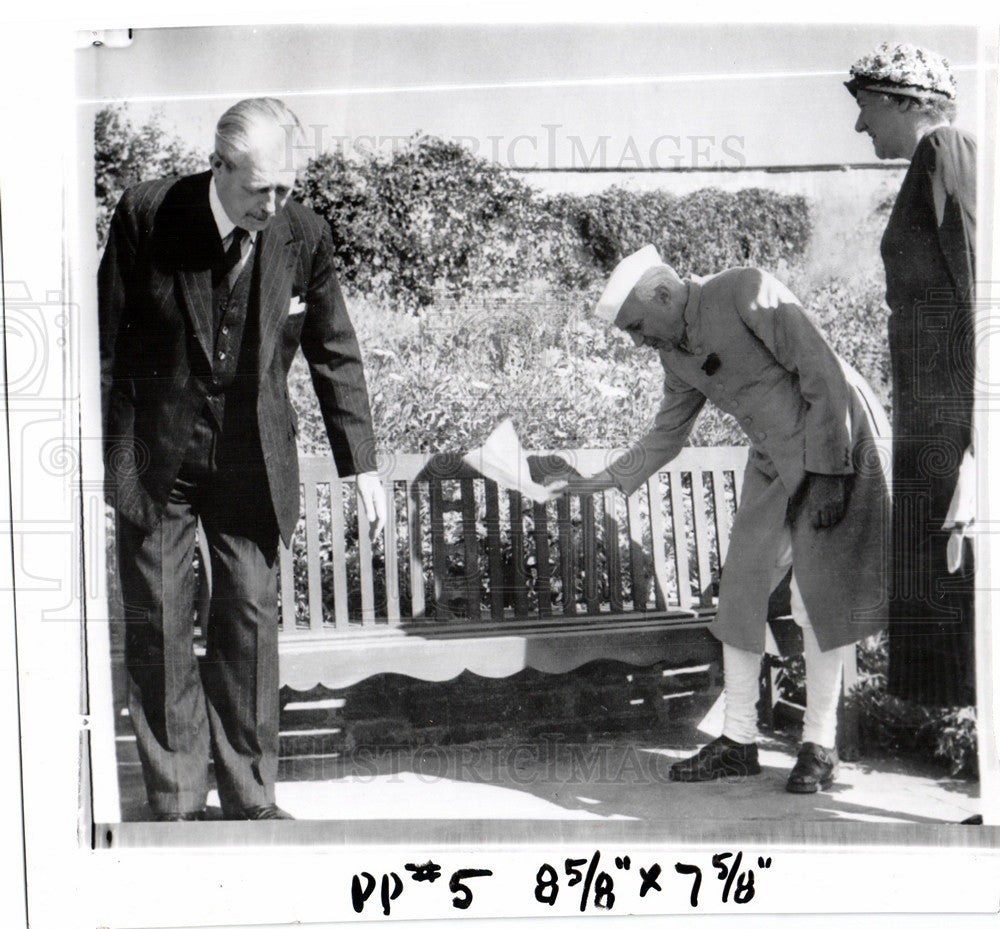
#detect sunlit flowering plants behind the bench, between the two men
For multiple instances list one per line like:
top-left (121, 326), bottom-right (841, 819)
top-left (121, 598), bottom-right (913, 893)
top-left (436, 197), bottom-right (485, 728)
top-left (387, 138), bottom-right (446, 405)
top-left (290, 296), bottom-right (746, 453)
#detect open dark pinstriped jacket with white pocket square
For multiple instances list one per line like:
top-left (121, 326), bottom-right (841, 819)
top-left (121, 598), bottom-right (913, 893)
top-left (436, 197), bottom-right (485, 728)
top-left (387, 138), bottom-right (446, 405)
top-left (98, 172), bottom-right (376, 543)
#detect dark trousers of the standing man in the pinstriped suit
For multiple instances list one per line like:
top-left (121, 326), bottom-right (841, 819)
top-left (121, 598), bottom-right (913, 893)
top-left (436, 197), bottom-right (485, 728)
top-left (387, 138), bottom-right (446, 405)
top-left (117, 400), bottom-right (278, 813)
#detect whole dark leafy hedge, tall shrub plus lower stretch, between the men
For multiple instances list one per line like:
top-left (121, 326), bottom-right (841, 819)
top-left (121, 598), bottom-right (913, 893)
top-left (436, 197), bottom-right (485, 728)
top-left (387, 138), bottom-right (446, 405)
top-left (300, 135), bottom-right (809, 310)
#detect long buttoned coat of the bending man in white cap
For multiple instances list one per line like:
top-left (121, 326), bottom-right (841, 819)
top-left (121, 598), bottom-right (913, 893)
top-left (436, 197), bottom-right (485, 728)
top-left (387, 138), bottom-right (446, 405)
top-left (609, 268), bottom-right (888, 651)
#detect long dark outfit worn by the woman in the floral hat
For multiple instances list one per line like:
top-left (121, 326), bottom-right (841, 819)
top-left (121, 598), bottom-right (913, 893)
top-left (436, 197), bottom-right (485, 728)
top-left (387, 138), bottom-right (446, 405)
top-left (882, 127), bottom-right (976, 706)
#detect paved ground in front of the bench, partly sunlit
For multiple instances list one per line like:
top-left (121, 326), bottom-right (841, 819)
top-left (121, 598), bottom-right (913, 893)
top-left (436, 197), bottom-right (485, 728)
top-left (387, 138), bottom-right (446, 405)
top-left (115, 737), bottom-right (979, 824)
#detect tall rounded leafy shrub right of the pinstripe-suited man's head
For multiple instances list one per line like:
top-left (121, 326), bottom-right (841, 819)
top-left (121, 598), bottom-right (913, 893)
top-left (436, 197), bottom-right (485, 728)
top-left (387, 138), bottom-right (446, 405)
top-left (292, 135), bottom-right (584, 310)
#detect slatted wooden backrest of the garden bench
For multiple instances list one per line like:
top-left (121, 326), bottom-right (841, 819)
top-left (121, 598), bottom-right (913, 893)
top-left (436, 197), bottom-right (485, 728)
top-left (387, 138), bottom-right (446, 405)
top-left (279, 447), bottom-right (746, 636)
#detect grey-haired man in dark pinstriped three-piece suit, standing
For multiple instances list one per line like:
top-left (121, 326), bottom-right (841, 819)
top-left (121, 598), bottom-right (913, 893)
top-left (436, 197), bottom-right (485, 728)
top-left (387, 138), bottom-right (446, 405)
top-left (98, 98), bottom-right (385, 821)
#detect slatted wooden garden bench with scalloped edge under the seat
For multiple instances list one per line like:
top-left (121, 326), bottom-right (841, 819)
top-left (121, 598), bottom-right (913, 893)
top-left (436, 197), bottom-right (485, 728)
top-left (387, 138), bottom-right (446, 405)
top-left (266, 447), bottom-right (746, 690)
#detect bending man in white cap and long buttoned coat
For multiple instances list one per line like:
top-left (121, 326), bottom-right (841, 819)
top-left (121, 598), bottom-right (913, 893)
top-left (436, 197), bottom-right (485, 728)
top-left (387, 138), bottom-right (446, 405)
top-left (567, 246), bottom-right (888, 793)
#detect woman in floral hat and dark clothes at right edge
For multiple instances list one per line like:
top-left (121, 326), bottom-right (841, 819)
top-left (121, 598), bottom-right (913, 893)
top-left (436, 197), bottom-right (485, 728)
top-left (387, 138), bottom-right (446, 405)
top-left (846, 43), bottom-right (976, 706)
